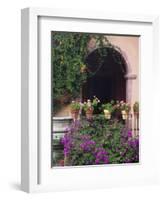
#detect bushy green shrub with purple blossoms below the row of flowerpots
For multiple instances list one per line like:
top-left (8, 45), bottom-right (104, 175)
top-left (61, 115), bottom-right (139, 166)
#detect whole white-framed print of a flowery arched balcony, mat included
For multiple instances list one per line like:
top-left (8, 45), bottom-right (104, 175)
top-left (21, 8), bottom-right (158, 192)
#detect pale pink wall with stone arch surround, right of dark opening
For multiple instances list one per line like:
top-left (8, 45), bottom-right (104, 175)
top-left (88, 35), bottom-right (139, 104)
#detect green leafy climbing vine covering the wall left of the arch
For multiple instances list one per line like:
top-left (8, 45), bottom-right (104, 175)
top-left (52, 32), bottom-right (107, 110)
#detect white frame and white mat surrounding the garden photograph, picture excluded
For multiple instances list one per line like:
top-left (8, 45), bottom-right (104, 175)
top-left (21, 8), bottom-right (159, 192)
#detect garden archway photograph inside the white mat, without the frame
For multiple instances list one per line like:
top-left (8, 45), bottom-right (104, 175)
top-left (51, 31), bottom-right (140, 167)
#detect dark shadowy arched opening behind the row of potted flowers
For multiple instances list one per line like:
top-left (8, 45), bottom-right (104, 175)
top-left (82, 47), bottom-right (127, 103)
